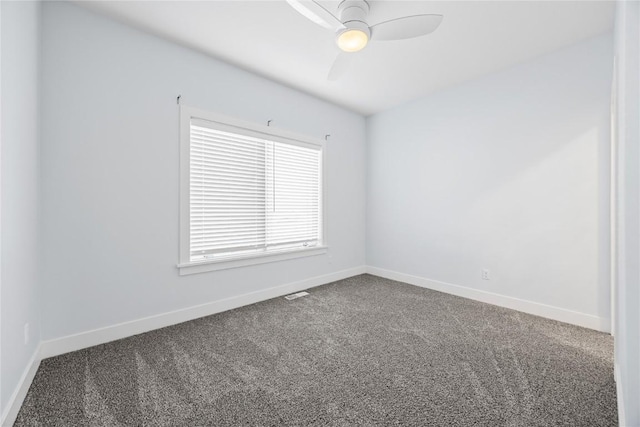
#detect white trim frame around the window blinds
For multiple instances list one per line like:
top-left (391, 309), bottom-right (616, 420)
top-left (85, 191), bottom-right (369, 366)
top-left (178, 105), bottom-right (328, 276)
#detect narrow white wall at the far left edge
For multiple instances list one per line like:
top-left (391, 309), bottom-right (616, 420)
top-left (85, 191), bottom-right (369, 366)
top-left (0, 2), bottom-right (40, 422)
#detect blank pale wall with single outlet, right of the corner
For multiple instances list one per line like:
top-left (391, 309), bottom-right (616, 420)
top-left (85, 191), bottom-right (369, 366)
top-left (367, 35), bottom-right (613, 329)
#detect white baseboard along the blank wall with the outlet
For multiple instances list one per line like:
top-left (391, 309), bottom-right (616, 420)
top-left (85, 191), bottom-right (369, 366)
top-left (367, 266), bottom-right (611, 332)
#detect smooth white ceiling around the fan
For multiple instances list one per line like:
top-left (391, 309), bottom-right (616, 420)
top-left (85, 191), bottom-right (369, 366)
top-left (74, 0), bottom-right (614, 115)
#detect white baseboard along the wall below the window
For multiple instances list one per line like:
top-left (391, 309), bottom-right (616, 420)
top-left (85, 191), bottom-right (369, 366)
top-left (40, 266), bottom-right (366, 359)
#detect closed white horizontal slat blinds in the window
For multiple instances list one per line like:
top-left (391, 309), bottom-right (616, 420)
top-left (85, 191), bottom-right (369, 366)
top-left (189, 120), bottom-right (322, 261)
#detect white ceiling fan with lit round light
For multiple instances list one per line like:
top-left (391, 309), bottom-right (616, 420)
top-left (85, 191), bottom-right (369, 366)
top-left (287, 0), bottom-right (442, 80)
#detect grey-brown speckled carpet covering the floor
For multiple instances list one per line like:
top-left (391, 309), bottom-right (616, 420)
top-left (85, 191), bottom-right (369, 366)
top-left (16, 275), bottom-right (617, 427)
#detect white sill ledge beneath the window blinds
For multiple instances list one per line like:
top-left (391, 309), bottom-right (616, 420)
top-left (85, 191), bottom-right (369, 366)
top-left (178, 246), bottom-right (329, 276)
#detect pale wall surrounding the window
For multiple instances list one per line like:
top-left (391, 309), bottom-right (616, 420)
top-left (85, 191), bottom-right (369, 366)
top-left (41, 2), bottom-right (365, 340)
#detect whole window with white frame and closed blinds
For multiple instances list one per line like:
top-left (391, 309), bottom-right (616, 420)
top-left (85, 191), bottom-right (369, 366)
top-left (179, 106), bottom-right (326, 274)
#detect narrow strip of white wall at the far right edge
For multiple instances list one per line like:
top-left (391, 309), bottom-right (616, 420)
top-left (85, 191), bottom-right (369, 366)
top-left (614, 2), bottom-right (640, 426)
